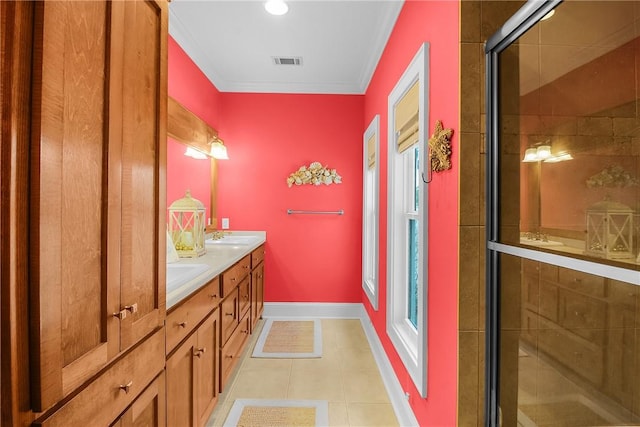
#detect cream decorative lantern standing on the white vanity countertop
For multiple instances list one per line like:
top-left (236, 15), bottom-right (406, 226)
top-left (169, 190), bottom-right (206, 258)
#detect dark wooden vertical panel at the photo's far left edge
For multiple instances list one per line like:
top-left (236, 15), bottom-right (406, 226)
top-left (0, 2), bottom-right (34, 426)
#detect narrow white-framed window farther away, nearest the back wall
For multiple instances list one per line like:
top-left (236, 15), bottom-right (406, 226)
top-left (362, 114), bottom-right (380, 311)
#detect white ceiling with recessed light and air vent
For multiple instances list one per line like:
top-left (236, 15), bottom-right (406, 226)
top-left (169, 0), bottom-right (403, 94)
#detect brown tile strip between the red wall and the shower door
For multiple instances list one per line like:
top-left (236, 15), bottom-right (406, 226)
top-left (458, 1), bottom-right (525, 427)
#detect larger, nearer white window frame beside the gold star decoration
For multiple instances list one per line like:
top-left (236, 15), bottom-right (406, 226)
top-left (387, 43), bottom-right (429, 397)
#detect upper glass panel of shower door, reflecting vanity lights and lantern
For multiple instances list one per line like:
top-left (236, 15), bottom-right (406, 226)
top-left (500, 2), bottom-right (640, 265)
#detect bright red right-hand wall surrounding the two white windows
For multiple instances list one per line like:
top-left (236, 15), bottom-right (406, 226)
top-left (362, 1), bottom-right (460, 426)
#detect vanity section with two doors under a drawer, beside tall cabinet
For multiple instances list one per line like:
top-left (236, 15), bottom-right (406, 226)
top-left (166, 294), bottom-right (220, 426)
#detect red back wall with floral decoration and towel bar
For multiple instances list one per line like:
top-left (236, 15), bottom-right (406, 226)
top-left (218, 93), bottom-right (364, 303)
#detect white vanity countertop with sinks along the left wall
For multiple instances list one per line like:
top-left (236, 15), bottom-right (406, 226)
top-left (166, 231), bottom-right (267, 310)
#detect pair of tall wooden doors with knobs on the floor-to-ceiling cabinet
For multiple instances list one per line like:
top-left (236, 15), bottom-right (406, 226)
top-left (29, 1), bottom-right (168, 411)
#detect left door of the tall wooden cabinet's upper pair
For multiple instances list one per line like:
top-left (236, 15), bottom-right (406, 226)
top-left (29, 1), bottom-right (121, 411)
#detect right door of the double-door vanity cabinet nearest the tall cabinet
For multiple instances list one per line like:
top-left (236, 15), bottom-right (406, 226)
top-left (196, 309), bottom-right (220, 426)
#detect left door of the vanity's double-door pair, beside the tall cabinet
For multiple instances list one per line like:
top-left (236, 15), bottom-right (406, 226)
top-left (166, 333), bottom-right (198, 427)
